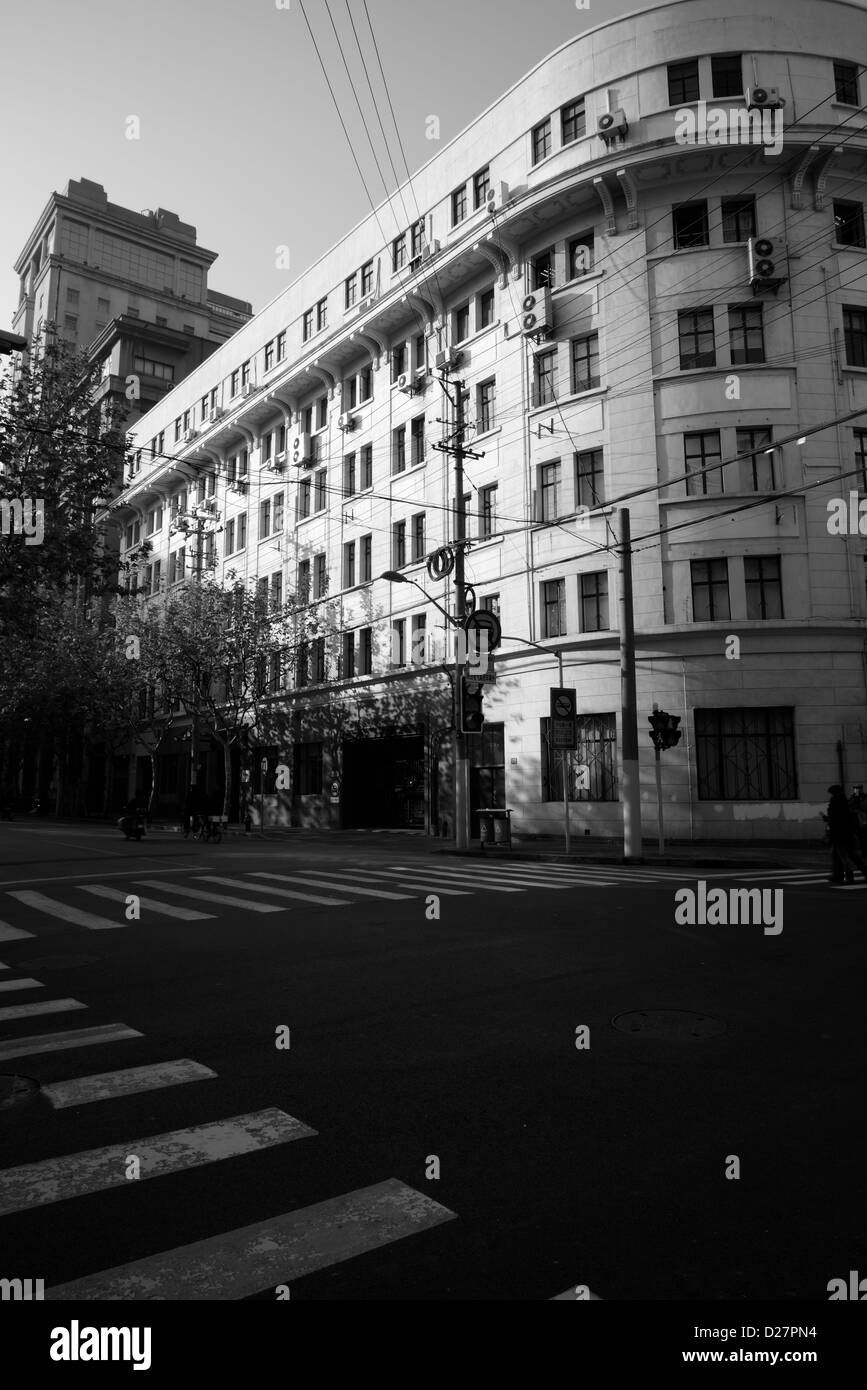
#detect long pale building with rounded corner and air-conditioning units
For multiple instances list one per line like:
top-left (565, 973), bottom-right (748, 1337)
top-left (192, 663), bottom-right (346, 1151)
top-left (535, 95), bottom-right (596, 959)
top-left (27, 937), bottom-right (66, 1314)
top-left (106, 0), bottom-right (867, 838)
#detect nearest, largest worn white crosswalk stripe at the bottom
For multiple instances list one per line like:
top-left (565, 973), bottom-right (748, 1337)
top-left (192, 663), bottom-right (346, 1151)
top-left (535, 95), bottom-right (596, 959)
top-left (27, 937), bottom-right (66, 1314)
top-left (46, 1177), bottom-right (456, 1301)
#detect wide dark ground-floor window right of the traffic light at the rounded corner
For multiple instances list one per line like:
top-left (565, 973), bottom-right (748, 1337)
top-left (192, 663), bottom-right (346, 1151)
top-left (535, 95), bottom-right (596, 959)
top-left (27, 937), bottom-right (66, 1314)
top-left (695, 706), bottom-right (798, 801)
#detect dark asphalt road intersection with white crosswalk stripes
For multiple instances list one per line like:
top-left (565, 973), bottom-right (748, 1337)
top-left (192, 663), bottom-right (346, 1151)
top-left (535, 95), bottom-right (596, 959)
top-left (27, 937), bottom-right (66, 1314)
top-left (0, 823), bottom-right (867, 1301)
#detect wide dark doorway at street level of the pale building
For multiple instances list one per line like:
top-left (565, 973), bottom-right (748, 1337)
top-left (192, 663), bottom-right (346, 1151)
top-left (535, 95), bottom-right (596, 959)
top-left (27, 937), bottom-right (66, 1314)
top-left (342, 735), bottom-right (425, 830)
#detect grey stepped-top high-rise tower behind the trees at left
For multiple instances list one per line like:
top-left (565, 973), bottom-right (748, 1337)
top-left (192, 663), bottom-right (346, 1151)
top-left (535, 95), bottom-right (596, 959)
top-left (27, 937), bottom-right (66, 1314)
top-left (13, 179), bottom-right (253, 424)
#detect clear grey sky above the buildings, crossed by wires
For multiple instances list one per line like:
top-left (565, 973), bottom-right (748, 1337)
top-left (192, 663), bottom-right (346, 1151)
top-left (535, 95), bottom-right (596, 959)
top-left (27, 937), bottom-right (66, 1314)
top-left (0, 0), bottom-right (653, 318)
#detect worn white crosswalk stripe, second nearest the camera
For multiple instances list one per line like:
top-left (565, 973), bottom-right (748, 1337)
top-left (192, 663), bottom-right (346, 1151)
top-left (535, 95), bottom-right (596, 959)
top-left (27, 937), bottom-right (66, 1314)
top-left (0, 1109), bottom-right (315, 1216)
